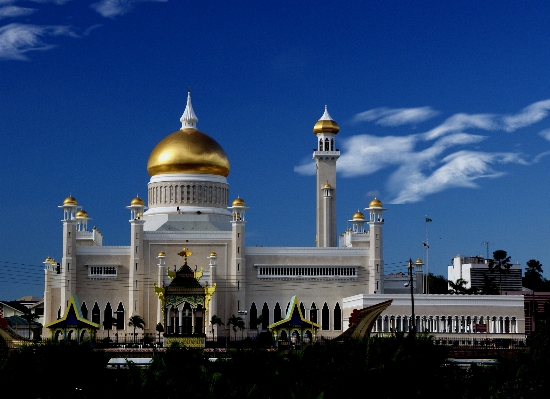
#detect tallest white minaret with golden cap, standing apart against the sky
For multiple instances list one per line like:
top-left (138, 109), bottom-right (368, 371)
top-left (313, 105), bottom-right (340, 247)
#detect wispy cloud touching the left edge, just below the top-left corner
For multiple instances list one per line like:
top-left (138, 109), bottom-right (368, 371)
top-left (0, 23), bottom-right (77, 60)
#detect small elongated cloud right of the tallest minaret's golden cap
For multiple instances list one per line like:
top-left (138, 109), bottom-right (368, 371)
top-left (353, 107), bottom-right (439, 126)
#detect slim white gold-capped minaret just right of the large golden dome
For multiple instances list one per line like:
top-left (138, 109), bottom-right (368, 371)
top-left (226, 197), bottom-right (249, 330)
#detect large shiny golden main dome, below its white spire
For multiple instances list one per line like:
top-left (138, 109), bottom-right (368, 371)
top-left (147, 128), bottom-right (229, 177)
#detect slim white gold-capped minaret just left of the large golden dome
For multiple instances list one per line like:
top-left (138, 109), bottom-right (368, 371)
top-left (126, 197), bottom-right (145, 317)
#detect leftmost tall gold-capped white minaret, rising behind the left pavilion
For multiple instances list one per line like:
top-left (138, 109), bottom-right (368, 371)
top-left (59, 196), bottom-right (81, 314)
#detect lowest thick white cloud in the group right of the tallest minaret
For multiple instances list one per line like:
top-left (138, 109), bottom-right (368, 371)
top-left (389, 151), bottom-right (527, 204)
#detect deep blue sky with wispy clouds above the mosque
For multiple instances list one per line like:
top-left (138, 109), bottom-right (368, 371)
top-left (0, 0), bottom-right (550, 299)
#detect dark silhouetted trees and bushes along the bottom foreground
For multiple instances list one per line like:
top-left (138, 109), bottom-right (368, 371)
top-left (0, 321), bottom-right (550, 399)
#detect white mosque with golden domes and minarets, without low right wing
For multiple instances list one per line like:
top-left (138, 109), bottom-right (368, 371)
top-left (44, 93), bottom-right (386, 336)
